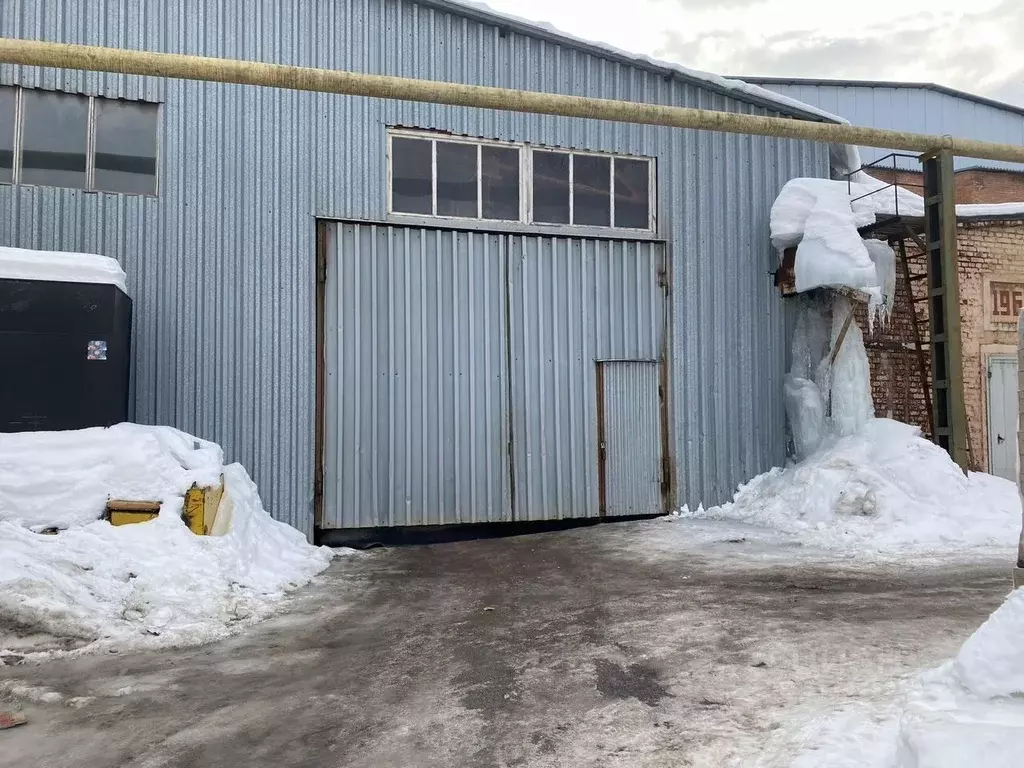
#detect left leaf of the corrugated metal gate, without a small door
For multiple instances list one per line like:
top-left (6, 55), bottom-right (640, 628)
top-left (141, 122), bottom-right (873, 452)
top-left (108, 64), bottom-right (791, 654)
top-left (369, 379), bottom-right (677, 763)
top-left (323, 224), bottom-right (511, 527)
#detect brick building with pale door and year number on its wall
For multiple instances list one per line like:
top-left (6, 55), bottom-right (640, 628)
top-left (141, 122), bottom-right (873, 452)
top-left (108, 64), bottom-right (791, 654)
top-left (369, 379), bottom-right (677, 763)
top-left (865, 215), bottom-right (1024, 479)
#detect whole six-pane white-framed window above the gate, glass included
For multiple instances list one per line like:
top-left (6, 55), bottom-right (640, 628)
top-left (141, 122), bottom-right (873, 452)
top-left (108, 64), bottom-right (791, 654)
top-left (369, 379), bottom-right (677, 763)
top-left (388, 130), bottom-right (656, 232)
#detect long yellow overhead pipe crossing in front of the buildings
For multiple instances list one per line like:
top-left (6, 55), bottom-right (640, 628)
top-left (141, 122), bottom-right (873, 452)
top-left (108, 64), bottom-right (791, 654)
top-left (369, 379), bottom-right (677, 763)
top-left (0, 38), bottom-right (1024, 163)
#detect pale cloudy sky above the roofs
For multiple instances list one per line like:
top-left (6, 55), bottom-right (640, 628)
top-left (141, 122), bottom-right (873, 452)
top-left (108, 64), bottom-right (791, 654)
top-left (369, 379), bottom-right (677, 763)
top-left (488, 0), bottom-right (1024, 106)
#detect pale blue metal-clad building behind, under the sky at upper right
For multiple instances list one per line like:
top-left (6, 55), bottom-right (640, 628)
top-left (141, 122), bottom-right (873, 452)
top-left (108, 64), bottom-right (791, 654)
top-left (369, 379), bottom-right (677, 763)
top-left (743, 77), bottom-right (1024, 171)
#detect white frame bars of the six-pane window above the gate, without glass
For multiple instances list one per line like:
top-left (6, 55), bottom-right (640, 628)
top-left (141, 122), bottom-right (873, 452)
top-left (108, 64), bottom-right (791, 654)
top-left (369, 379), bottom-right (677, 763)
top-left (385, 127), bottom-right (657, 238)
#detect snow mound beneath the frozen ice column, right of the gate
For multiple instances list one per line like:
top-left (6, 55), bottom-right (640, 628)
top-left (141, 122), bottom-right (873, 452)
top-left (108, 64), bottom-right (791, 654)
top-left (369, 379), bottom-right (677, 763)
top-left (679, 419), bottom-right (1021, 551)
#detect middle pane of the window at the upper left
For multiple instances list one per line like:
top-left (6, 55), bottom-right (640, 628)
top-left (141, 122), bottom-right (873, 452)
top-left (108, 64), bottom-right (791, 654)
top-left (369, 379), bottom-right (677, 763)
top-left (22, 90), bottom-right (89, 189)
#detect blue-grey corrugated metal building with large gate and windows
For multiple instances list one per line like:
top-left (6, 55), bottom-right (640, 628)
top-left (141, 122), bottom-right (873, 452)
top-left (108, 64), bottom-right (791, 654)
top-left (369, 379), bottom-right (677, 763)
top-left (0, 0), bottom-right (828, 534)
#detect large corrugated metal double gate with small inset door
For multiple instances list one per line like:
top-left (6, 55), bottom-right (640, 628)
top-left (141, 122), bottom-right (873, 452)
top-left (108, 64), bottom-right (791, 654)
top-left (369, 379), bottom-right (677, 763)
top-left (319, 223), bottom-right (666, 528)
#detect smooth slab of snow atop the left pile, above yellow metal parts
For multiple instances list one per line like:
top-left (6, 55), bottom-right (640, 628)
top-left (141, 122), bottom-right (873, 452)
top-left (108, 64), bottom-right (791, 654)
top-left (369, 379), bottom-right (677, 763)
top-left (0, 424), bottom-right (224, 529)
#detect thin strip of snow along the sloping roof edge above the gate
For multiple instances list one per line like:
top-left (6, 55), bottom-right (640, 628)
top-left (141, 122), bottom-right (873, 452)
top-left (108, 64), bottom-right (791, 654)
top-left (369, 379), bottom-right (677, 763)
top-left (416, 0), bottom-right (848, 123)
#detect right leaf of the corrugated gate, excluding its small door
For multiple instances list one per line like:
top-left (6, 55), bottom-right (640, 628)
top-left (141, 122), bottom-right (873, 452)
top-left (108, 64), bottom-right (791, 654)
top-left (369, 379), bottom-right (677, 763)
top-left (509, 236), bottom-right (666, 520)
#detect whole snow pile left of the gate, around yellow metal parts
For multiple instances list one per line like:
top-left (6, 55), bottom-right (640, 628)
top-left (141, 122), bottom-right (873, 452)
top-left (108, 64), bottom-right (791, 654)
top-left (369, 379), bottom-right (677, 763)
top-left (0, 424), bottom-right (333, 650)
